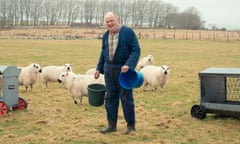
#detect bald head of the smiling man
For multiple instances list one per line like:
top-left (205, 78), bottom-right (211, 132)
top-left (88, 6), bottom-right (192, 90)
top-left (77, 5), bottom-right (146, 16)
top-left (104, 12), bottom-right (120, 33)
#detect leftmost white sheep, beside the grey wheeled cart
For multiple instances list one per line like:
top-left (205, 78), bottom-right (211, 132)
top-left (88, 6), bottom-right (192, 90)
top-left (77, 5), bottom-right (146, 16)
top-left (18, 63), bottom-right (42, 91)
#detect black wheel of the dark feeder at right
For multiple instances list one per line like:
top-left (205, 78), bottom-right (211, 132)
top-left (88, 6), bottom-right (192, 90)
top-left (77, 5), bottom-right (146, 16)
top-left (191, 105), bottom-right (206, 119)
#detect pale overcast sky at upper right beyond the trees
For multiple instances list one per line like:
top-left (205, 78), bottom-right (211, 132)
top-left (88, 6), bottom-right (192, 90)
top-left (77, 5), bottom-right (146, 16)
top-left (163, 0), bottom-right (240, 30)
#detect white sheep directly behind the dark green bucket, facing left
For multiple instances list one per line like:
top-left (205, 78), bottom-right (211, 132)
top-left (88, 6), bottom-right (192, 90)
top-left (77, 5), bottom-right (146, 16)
top-left (58, 72), bottom-right (105, 104)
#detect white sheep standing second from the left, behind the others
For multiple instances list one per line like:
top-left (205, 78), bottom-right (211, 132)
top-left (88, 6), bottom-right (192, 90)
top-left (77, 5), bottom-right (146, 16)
top-left (41, 63), bottom-right (72, 88)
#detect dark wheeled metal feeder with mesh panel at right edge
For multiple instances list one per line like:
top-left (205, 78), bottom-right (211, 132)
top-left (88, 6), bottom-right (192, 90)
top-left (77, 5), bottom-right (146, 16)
top-left (191, 68), bottom-right (240, 119)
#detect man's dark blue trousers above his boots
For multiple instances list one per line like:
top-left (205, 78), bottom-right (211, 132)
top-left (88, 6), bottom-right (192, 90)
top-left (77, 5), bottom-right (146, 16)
top-left (104, 67), bottom-right (135, 127)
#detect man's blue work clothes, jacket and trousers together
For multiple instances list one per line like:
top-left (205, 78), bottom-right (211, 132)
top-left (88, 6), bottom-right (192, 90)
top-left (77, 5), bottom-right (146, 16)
top-left (97, 26), bottom-right (140, 127)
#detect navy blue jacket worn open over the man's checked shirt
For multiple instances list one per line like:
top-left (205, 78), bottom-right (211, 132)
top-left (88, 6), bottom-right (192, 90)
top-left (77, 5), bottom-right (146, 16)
top-left (97, 26), bottom-right (140, 74)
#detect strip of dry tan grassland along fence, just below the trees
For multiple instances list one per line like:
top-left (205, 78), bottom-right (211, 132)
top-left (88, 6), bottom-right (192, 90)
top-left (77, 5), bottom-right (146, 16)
top-left (0, 27), bottom-right (240, 41)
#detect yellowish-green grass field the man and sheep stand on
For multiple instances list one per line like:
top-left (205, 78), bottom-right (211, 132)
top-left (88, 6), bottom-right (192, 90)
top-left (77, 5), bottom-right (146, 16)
top-left (0, 40), bottom-right (240, 144)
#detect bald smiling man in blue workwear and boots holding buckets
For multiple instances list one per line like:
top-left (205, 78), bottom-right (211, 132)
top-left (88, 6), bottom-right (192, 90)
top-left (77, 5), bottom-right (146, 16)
top-left (95, 12), bottom-right (140, 134)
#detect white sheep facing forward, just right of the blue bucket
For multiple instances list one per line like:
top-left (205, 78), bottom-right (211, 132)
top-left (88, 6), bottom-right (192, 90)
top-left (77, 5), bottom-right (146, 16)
top-left (140, 65), bottom-right (170, 91)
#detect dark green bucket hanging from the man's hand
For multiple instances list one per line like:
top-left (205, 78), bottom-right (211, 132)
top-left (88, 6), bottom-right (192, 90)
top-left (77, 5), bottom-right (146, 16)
top-left (88, 84), bottom-right (106, 106)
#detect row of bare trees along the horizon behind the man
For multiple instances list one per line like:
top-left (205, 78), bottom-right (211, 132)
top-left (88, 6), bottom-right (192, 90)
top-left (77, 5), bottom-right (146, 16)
top-left (0, 0), bottom-right (204, 29)
